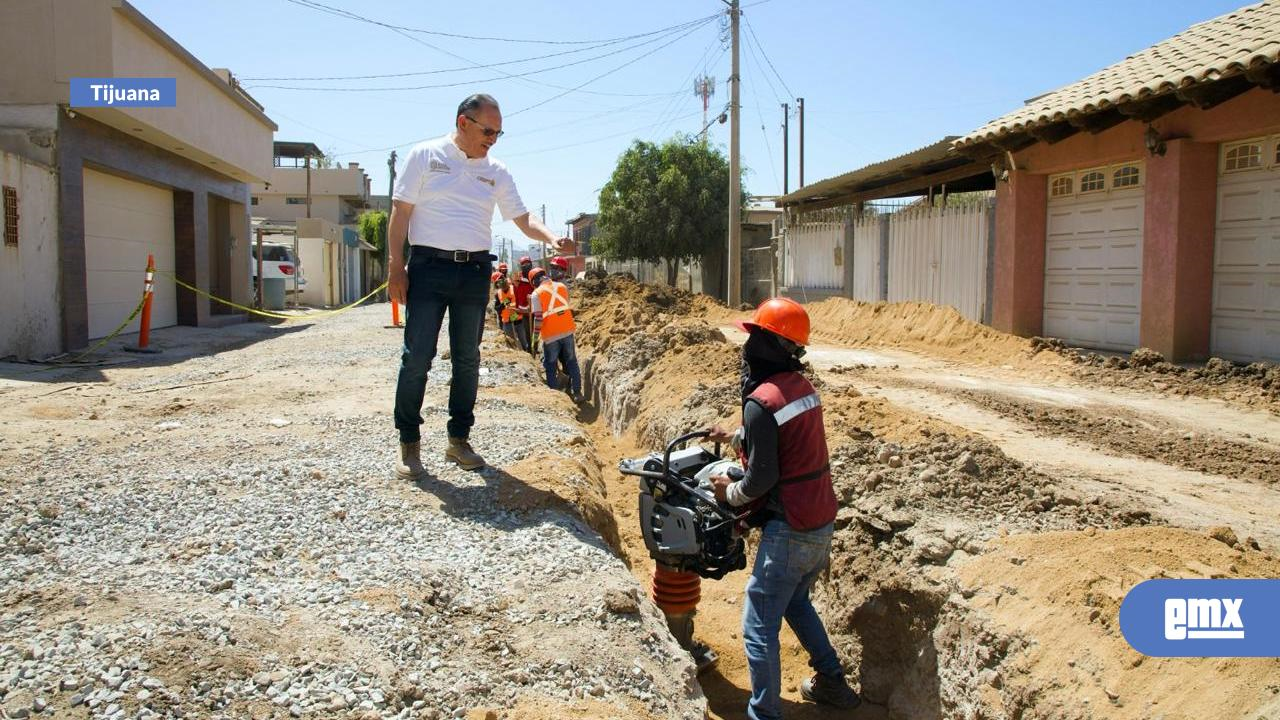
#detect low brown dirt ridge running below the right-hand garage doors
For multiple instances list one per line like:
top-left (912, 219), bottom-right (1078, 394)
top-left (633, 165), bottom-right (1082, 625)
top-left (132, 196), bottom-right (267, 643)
top-left (1030, 337), bottom-right (1280, 413)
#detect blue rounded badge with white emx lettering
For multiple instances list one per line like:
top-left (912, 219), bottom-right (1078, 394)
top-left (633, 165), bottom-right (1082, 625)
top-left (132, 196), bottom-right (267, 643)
top-left (1120, 579), bottom-right (1280, 657)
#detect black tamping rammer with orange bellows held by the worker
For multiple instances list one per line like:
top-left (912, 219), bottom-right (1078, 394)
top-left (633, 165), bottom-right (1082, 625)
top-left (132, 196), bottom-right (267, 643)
top-left (618, 432), bottom-right (746, 673)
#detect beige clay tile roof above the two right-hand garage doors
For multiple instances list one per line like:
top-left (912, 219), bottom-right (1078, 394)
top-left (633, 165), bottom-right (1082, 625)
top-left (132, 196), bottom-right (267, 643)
top-left (956, 0), bottom-right (1280, 147)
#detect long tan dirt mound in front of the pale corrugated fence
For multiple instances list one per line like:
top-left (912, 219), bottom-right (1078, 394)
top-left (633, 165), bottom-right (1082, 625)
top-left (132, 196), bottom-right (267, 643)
top-left (805, 297), bottom-right (1044, 365)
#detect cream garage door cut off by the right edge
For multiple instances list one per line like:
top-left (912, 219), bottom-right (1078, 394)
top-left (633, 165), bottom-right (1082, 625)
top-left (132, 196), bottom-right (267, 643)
top-left (1210, 136), bottom-right (1280, 360)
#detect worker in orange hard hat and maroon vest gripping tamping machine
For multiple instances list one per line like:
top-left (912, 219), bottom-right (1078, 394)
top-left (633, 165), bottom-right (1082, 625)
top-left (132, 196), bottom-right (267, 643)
top-left (710, 297), bottom-right (861, 720)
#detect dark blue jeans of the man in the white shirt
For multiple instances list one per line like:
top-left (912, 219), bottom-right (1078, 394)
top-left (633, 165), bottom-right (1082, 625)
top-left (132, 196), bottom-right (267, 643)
top-left (396, 255), bottom-right (493, 442)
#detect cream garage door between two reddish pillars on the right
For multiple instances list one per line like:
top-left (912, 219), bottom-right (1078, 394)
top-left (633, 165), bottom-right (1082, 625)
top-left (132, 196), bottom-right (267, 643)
top-left (1044, 163), bottom-right (1144, 351)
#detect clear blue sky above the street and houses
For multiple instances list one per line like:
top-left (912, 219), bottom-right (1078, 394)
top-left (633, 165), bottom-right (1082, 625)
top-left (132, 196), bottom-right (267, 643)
top-left (131, 0), bottom-right (1240, 245)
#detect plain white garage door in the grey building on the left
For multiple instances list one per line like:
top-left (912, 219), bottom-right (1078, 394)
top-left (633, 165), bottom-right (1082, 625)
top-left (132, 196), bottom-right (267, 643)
top-left (84, 168), bottom-right (178, 338)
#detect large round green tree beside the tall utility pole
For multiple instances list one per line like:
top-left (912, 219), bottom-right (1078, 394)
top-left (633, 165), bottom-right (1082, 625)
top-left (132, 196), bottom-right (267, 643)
top-left (591, 135), bottom-right (746, 286)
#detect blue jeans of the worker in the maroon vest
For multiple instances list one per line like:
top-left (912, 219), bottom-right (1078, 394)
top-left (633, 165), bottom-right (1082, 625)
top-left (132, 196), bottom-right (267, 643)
top-left (742, 520), bottom-right (844, 720)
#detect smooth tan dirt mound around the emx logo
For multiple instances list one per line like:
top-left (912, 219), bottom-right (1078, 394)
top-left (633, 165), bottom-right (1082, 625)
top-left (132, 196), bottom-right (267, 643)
top-left (959, 520), bottom-right (1280, 720)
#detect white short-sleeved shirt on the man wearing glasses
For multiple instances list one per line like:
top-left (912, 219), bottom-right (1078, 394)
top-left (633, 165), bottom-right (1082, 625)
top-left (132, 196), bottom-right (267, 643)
top-left (392, 135), bottom-right (529, 251)
